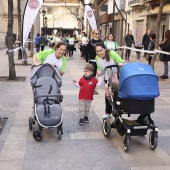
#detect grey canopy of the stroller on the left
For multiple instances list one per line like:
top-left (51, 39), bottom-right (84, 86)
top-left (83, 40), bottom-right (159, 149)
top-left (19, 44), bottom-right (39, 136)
top-left (30, 63), bottom-right (62, 87)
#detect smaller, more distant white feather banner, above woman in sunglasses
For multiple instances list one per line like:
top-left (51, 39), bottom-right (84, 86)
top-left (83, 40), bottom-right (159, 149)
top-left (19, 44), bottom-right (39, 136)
top-left (85, 5), bottom-right (97, 30)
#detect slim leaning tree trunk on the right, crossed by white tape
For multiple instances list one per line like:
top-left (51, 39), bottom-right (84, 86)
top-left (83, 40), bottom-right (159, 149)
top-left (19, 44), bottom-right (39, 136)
top-left (151, 0), bottom-right (165, 69)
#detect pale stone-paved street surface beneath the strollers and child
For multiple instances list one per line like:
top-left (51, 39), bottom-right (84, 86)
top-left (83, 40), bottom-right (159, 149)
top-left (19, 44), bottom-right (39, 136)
top-left (0, 45), bottom-right (170, 170)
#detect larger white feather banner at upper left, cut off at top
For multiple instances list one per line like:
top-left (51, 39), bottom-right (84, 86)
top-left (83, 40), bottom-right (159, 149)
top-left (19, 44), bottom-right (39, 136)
top-left (22, 0), bottom-right (43, 47)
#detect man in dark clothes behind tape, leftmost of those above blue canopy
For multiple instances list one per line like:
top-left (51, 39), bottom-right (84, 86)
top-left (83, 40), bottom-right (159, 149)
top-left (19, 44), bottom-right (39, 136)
top-left (125, 30), bottom-right (135, 61)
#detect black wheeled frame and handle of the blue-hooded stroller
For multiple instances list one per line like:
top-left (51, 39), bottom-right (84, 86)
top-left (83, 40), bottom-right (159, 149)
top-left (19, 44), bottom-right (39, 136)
top-left (102, 65), bottom-right (158, 152)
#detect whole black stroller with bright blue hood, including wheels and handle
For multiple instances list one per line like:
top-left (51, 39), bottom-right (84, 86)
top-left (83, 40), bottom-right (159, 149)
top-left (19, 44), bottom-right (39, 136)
top-left (102, 62), bottom-right (160, 152)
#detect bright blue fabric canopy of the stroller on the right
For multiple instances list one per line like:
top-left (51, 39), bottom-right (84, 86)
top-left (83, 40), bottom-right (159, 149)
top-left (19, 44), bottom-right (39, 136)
top-left (119, 62), bottom-right (160, 100)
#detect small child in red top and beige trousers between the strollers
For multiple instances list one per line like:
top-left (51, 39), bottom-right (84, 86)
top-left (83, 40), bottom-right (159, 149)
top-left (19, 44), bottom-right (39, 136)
top-left (73, 64), bottom-right (102, 126)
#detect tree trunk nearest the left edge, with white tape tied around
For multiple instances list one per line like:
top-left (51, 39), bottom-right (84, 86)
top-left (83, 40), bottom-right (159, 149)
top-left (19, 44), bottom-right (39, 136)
top-left (7, 0), bottom-right (16, 80)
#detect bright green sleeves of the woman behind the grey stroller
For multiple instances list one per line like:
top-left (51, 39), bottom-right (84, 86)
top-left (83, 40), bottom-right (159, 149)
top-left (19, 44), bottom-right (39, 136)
top-left (36, 49), bottom-right (66, 72)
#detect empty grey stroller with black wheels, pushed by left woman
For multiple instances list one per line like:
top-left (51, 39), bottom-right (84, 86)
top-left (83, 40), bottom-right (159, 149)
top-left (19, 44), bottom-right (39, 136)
top-left (29, 64), bottom-right (63, 142)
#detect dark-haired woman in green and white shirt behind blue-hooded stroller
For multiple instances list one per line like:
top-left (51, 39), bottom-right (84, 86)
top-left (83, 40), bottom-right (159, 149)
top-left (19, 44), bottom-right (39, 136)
top-left (95, 42), bottom-right (124, 115)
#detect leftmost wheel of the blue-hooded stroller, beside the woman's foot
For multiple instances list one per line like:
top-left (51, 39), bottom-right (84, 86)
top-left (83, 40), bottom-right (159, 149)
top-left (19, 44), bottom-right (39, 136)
top-left (102, 117), bottom-right (111, 138)
